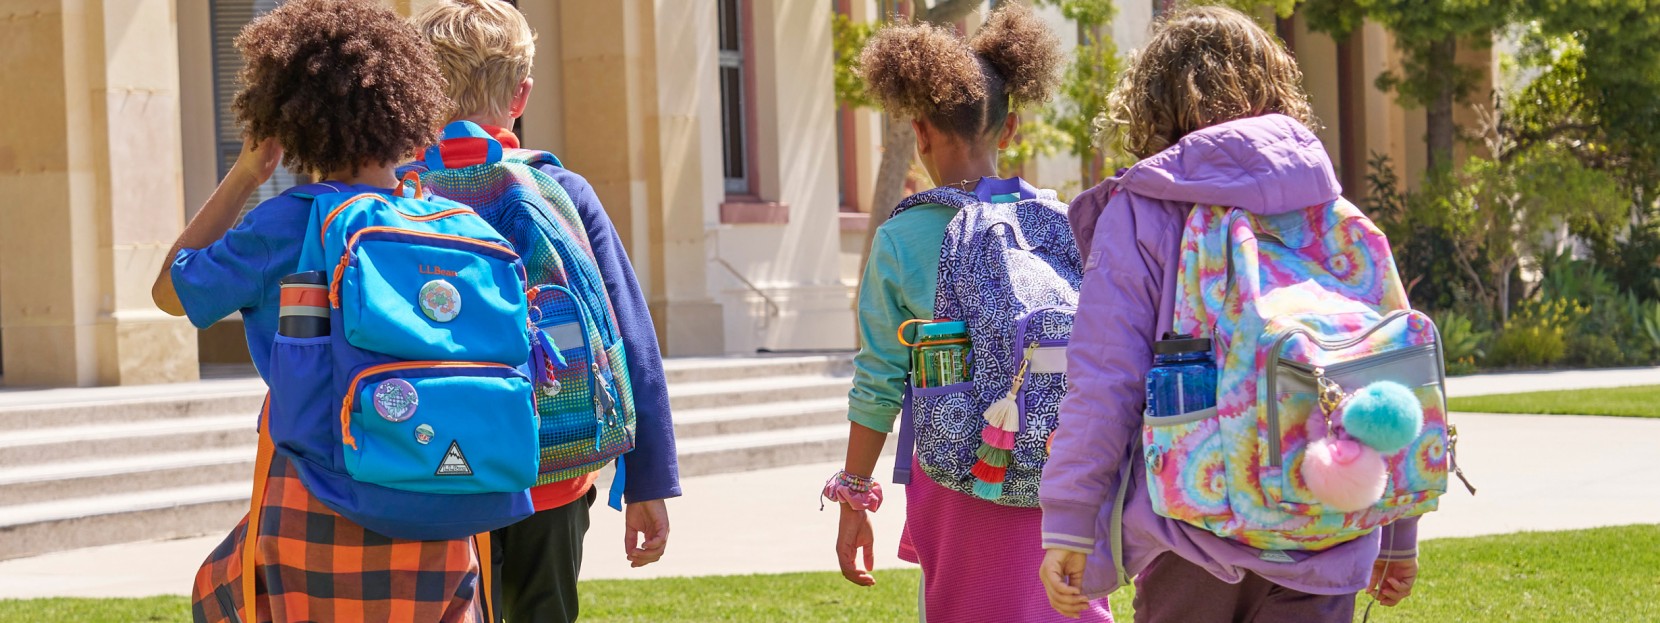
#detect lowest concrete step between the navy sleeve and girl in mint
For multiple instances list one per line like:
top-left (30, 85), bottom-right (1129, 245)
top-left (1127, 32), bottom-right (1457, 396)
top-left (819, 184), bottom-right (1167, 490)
top-left (677, 424), bottom-right (898, 478)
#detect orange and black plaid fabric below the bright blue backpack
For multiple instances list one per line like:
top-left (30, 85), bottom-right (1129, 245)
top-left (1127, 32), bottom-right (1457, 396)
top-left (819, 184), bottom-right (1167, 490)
top-left (191, 455), bottom-right (485, 623)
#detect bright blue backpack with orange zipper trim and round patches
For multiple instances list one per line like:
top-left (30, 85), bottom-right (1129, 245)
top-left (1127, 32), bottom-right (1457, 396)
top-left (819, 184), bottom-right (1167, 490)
top-left (267, 184), bottom-right (538, 540)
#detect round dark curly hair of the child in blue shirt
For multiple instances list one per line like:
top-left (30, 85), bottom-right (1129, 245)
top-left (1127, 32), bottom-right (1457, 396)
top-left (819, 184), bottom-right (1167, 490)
top-left (232, 0), bottom-right (453, 174)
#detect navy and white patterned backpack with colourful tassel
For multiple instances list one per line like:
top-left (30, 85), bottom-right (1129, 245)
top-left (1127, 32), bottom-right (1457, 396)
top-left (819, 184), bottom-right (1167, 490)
top-left (893, 178), bottom-right (1084, 507)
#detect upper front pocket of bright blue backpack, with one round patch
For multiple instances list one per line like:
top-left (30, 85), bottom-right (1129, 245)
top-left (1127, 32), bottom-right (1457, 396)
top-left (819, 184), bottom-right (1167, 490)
top-left (334, 226), bottom-right (530, 365)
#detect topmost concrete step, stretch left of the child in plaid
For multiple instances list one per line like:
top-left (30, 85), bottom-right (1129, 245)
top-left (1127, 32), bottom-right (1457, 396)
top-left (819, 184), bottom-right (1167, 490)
top-left (0, 377), bottom-right (266, 432)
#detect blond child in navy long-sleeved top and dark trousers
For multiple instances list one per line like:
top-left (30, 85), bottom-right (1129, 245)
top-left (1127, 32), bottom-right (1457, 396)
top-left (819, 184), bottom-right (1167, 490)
top-left (415, 0), bottom-right (681, 621)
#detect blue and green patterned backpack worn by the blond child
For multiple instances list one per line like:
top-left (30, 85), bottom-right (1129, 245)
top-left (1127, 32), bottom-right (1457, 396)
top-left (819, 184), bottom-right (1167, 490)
top-left (400, 121), bottom-right (636, 508)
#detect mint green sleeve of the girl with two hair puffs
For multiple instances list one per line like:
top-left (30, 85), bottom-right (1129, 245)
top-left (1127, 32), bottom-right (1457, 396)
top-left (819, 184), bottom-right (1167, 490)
top-left (847, 204), bottom-right (956, 434)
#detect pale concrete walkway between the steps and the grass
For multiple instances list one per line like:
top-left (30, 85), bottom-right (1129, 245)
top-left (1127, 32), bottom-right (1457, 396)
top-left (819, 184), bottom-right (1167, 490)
top-left (0, 369), bottom-right (1660, 598)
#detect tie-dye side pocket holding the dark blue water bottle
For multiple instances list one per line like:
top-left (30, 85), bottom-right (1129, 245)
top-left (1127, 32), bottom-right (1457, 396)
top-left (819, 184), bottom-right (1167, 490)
top-left (1142, 407), bottom-right (1230, 527)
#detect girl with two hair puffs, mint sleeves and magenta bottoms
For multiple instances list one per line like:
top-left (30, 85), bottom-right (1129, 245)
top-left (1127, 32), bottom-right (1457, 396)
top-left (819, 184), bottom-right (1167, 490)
top-left (825, 3), bottom-right (1111, 621)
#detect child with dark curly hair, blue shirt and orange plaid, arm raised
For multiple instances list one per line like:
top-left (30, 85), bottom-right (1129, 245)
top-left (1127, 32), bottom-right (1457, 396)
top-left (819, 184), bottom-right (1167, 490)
top-left (151, 0), bottom-right (481, 621)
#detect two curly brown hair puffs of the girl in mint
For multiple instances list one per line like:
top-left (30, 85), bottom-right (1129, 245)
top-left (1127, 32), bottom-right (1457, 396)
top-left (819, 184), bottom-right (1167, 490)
top-left (858, 2), bottom-right (1062, 138)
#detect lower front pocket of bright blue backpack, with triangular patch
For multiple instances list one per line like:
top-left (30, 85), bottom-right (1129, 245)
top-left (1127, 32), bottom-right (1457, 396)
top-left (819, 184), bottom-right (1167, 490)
top-left (340, 362), bottom-right (538, 493)
